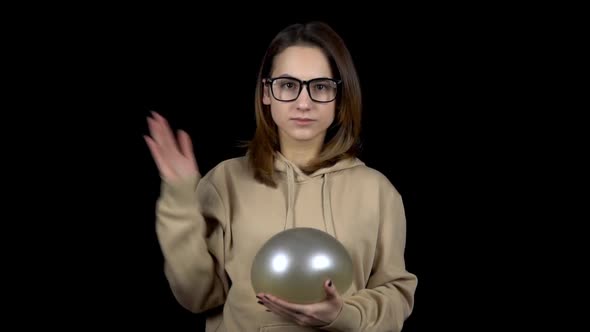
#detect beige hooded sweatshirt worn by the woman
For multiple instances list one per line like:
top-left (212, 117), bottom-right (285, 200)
top-left (156, 154), bottom-right (417, 332)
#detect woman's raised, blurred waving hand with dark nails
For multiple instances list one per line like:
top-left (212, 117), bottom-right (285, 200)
top-left (144, 112), bottom-right (199, 181)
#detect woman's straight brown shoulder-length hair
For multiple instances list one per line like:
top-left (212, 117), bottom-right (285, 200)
top-left (247, 22), bottom-right (362, 186)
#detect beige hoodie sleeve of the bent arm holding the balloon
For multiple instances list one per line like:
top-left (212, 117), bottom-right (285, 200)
top-left (322, 190), bottom-right (417, 332)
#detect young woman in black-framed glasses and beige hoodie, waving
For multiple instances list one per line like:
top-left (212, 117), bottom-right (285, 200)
top-left (145, 22), bottom-right (417, 332)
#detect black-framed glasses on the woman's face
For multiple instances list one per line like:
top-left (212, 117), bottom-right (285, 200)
top-left (265, 77), bottom-right (342, 103)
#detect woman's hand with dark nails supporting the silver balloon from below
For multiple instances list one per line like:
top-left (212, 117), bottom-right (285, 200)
top-left (256, 280), bottom-right (343, 327)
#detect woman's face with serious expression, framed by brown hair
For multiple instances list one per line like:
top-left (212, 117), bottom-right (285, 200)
top-left (262, 46), bottom-right (338, 148)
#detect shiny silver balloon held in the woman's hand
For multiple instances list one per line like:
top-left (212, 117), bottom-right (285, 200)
top-left (251, 227), bottom-right (353, 304)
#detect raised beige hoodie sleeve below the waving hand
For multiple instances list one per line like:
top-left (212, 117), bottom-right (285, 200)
top-left (156, 176), bottom-right (229, 313)
